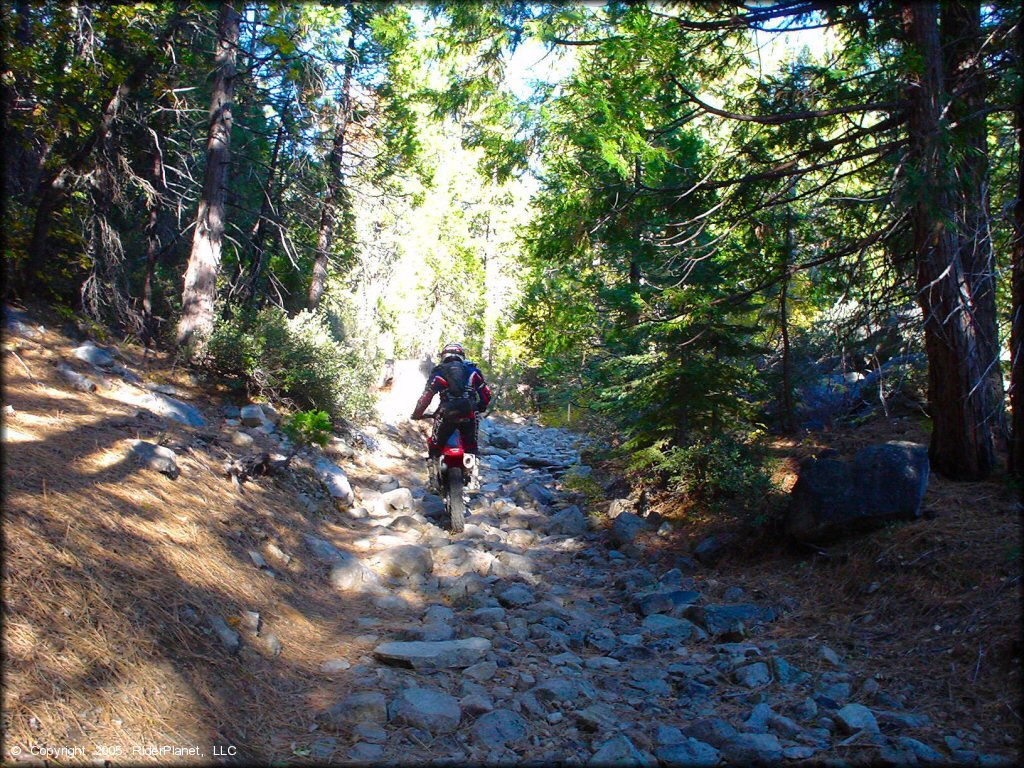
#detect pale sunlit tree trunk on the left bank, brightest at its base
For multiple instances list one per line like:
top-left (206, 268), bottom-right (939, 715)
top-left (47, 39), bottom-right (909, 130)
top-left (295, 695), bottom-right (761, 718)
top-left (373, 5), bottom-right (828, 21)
top-left (177, 3), bottom-right (240, 359)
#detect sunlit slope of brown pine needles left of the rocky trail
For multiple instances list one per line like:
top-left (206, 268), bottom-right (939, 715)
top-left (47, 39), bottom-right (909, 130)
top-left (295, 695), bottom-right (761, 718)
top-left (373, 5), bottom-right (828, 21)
top-left (3, 319), bottom-right (432, 763)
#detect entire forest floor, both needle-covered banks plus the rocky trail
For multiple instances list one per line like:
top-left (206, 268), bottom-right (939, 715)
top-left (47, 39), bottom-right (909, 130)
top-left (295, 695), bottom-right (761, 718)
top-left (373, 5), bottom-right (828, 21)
top-left (3, 309), bottom-right (1021, 765)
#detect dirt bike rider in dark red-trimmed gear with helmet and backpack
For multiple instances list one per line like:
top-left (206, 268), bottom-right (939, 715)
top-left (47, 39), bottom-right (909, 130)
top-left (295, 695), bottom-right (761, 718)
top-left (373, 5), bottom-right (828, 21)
top-left (413, 343), bottom-right (490, 489)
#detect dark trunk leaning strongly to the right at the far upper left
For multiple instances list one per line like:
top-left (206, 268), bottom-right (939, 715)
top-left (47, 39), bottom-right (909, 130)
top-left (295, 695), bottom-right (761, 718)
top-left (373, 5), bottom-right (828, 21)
top-left (18, 4), bottom-right (182, 296)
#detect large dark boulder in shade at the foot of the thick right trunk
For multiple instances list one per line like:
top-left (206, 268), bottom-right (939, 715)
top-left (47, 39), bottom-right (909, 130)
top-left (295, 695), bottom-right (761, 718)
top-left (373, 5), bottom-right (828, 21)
top-left (785, 442), bottom-right (929, 542)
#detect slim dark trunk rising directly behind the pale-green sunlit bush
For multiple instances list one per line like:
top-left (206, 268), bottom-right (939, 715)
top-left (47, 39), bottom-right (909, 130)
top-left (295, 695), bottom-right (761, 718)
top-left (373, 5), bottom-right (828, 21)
top-left (306, 16), bottom-right (358, 309)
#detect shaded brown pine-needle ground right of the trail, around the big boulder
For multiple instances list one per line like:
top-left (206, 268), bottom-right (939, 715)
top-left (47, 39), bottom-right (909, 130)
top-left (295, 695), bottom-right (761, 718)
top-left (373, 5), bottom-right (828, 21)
top-left (651, 418), bottom-right (1024, 754)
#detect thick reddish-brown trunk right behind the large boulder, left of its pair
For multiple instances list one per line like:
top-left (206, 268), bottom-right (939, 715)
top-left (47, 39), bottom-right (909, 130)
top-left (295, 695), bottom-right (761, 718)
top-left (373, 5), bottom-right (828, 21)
top-left (902, 2), bottom-right (995, 480)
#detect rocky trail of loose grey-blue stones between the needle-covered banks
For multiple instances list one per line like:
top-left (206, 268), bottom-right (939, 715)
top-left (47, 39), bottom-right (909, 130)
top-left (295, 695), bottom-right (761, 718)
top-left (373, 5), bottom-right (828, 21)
top-left (290, 421), bottom-right (1008, 766)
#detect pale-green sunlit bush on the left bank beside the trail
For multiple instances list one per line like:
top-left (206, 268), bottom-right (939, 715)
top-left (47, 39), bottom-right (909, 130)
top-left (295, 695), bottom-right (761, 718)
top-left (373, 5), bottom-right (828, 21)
top-left (208, 307), bottom-right (376, 421)
